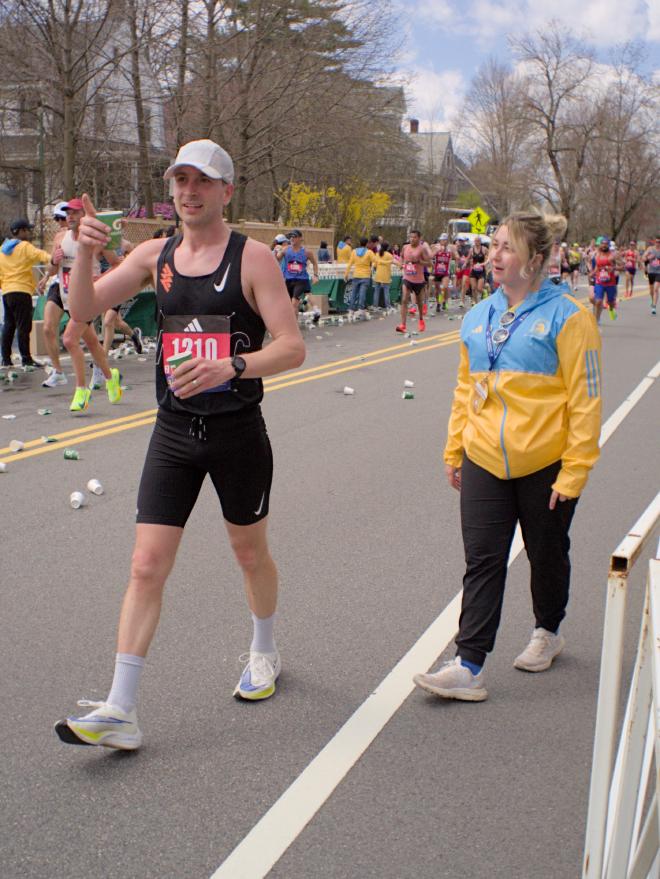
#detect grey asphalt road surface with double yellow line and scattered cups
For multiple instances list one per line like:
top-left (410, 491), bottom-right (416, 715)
top-left (0, 288), bottom-right (660, 879)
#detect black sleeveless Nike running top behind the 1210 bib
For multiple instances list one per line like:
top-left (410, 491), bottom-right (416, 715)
top-left (156, 231), bottom-right (266, 415)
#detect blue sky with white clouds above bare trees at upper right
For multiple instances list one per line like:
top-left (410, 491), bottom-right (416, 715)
top-left (397, 0), bottom-right (660, 131)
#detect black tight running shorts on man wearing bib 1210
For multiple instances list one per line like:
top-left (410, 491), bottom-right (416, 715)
top-left (136, 407), bottom-right (273, 528)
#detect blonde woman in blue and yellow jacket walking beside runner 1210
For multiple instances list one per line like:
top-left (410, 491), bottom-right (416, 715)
top-left (414, 211), bottom-right (601, 702)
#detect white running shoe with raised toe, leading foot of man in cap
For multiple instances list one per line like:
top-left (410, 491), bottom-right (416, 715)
top-left (55, 699), bottom-right (142, 751)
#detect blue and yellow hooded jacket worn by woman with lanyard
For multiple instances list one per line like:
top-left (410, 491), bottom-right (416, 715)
top-left (444, 280), bottom-right (601, 497)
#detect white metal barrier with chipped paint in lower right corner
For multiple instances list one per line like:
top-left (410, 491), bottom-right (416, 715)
top-left (582, 494), bottom-right (660, 879)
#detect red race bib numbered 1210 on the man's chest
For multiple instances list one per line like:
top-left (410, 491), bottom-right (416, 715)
top-left (161, 314), bottom-right (231, 394)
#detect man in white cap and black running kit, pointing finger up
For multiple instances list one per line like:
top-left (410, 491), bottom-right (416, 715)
top-left (56, 140), bottom-right (305, 750)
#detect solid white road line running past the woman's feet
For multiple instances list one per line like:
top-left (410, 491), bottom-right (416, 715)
top-left (211, 361), bottom-right (660, 879)
